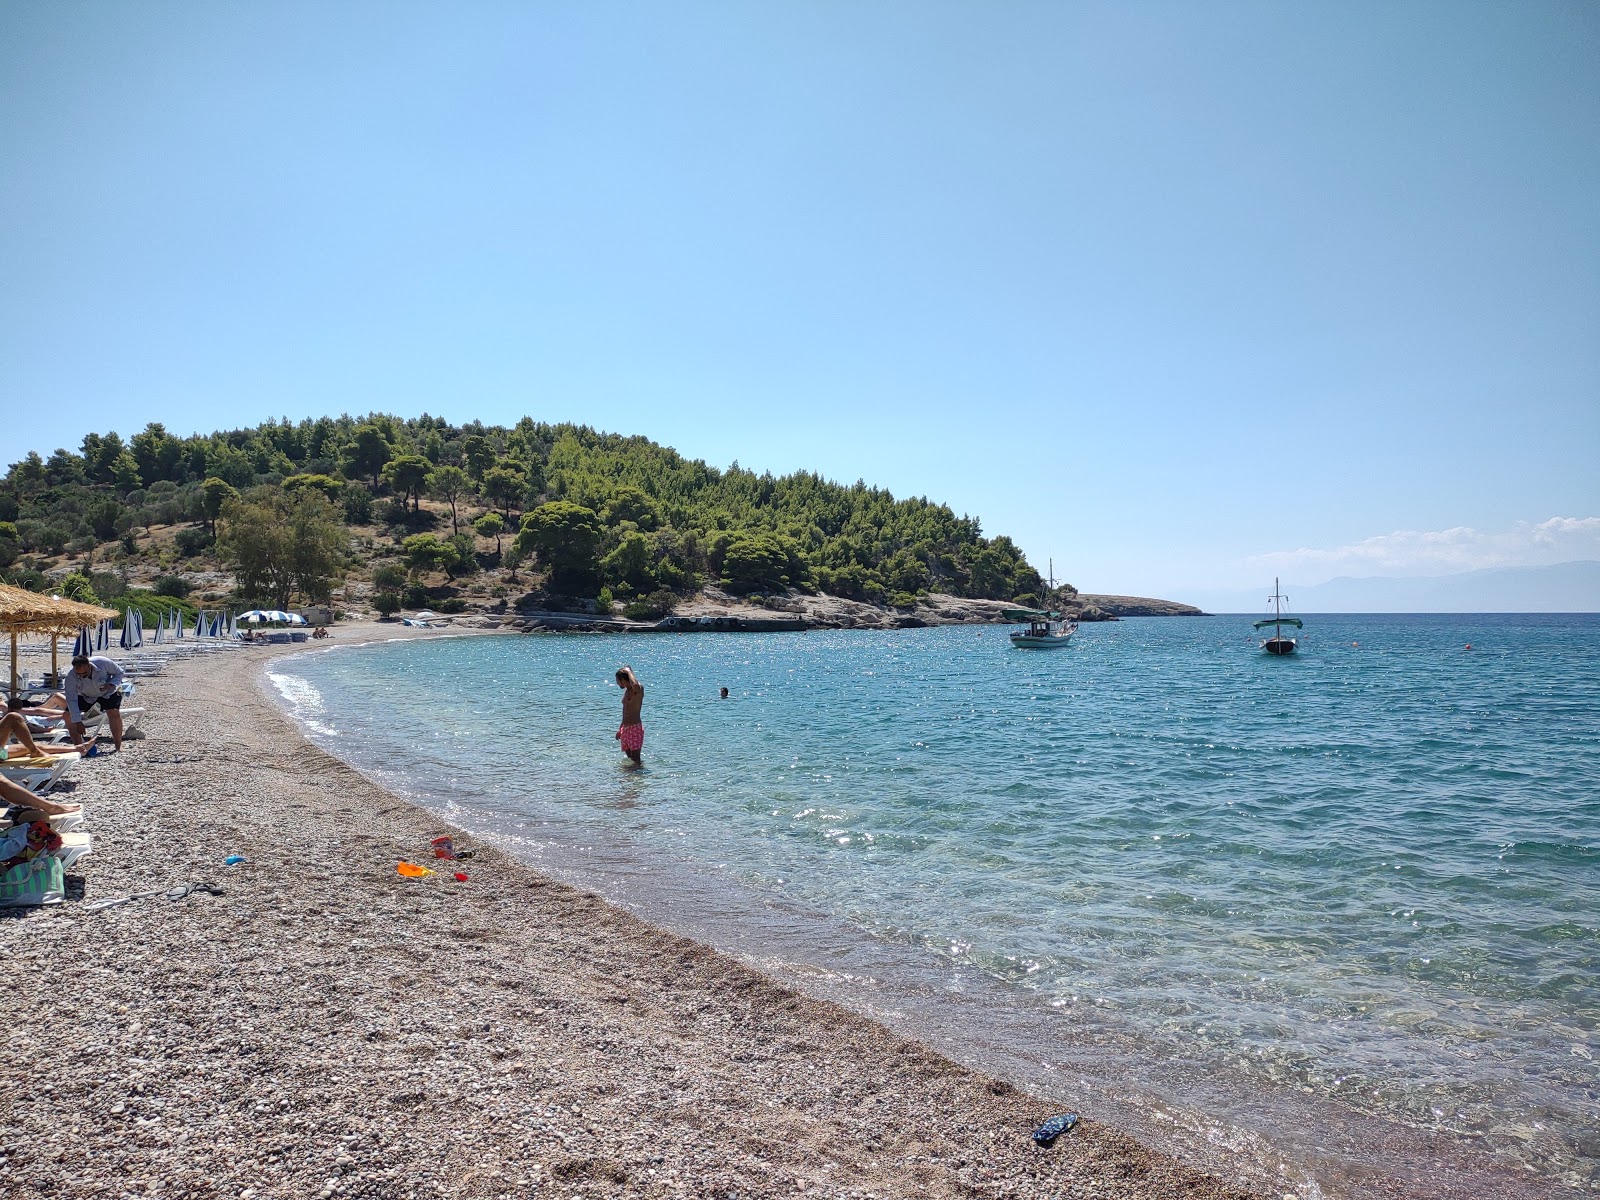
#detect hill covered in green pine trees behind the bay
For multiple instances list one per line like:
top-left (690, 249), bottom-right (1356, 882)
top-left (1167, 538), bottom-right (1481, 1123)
top-left (0, 414), bottom-right (1040, 611)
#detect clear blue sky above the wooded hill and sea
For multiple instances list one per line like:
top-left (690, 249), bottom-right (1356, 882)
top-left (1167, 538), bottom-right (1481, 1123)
top-left (0, 0), bottom-right (1600, 598)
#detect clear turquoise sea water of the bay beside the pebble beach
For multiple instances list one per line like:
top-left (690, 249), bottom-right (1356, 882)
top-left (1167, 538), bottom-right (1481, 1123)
top-left (274, 616), bottom-right (1600, 1186)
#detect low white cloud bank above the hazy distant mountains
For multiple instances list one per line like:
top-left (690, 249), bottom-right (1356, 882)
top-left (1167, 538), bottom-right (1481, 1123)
top-left (1245, 517), bottom-right (1600, 586)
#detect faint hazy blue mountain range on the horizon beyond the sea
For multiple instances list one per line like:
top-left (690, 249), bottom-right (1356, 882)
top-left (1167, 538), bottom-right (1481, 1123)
top-left (1186, 562), bottom-right (1600, 613)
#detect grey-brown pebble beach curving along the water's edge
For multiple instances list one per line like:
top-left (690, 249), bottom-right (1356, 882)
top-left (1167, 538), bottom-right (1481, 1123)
top-left (0, 627), bottom-right (1259, 1200)
